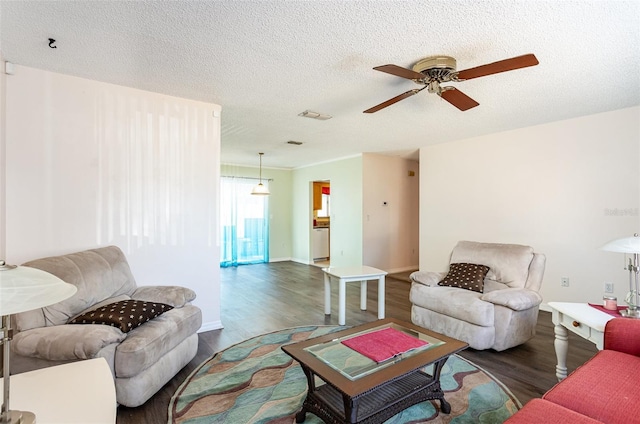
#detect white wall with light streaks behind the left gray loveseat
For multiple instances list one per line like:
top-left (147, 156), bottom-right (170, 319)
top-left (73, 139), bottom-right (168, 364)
top-left (2, 66), bottom-right (221, 330)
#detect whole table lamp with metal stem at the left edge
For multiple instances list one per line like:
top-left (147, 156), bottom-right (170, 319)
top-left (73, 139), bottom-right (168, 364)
top-left (0, 261), bottom-right (77, 424)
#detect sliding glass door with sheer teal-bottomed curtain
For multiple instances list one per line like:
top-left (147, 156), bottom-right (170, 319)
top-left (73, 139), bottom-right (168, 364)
top-left (220, 177), bottom-right (269, 267)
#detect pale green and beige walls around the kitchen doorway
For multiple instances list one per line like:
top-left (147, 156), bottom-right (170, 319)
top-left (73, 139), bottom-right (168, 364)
top-left (292, 154), bottom-right (419, 272)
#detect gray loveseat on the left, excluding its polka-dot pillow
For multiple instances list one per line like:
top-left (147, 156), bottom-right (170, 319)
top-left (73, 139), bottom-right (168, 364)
top-left (11, 246), bottom-right (202, 407)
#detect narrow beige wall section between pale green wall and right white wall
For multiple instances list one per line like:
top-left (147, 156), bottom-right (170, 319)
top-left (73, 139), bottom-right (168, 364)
top-left (362, 153), bottom-right (420, 272)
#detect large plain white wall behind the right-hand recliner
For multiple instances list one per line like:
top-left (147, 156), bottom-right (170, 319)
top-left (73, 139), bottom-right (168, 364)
top-left (420, 107), bottom-right (640, 307)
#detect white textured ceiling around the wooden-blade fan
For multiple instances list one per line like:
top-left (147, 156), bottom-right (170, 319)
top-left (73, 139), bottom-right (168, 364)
top-left (0, 0), bottom-right (640, 168)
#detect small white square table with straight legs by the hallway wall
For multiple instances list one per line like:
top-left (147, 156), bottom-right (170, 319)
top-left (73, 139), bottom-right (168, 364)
top-left (322, 265), bottom-right (387, 325)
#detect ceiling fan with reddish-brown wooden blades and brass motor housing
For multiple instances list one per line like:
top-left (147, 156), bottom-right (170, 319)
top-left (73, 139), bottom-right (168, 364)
top-left (363, 53), bottom-right (539, 113)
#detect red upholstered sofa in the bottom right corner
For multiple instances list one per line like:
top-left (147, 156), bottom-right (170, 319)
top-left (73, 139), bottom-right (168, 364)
top-left (505, 318), bottom-right (640, 424)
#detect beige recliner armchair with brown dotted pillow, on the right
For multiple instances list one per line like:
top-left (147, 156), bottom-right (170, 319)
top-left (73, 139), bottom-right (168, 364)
top-left (409, 241), bottom-right (546, 351)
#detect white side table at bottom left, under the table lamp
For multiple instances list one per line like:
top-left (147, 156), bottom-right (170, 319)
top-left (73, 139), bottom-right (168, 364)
top-left (0, 358), bottom-right (118, 424)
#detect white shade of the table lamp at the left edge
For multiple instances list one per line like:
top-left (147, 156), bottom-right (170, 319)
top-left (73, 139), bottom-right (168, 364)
top-left (0, 266), bottom-right (78, 316)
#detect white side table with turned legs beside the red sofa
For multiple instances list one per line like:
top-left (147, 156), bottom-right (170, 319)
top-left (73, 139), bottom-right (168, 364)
top-left (549, 302), bottom-right (614, 381)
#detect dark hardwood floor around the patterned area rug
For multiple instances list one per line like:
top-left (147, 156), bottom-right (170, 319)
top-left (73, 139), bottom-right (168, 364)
top-left (117, 262), bottom-right (597, 424)
